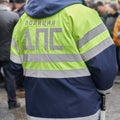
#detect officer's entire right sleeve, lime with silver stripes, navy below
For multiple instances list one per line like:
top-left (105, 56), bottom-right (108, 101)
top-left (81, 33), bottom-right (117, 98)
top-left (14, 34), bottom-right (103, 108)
top-left (78, 9), bottom-right (117, 94)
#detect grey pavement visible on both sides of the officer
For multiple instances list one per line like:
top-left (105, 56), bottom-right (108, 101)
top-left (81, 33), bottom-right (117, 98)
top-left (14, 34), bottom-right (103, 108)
top-left (0, 77), bottom-right (120, 120)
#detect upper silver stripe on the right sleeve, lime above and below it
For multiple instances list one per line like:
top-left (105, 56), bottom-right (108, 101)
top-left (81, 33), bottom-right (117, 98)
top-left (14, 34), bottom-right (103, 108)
top-left (78, 23), bottom-right (107, 48)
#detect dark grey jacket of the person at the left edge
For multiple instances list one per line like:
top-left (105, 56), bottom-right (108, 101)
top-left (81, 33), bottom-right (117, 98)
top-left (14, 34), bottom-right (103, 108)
top-left (0, 4), bottom-right (19, 61)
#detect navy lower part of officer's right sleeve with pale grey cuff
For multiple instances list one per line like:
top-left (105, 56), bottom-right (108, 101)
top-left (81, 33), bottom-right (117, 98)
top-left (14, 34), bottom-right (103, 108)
top-left (86, 45), bottom-right (117, 94)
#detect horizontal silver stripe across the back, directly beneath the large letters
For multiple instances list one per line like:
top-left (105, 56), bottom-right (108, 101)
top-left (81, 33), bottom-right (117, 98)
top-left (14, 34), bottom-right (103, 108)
top-left (23, 54), bottom-right (82, 62)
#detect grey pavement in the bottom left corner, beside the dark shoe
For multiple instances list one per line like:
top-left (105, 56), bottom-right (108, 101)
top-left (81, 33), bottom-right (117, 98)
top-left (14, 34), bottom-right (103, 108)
top-left (0, 89), bottom-right (27, 120)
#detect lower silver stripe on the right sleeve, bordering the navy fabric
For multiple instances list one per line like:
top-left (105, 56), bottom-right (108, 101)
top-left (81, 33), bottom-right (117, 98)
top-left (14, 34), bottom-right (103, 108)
top-left (82, 38), bottom-right (114, 61)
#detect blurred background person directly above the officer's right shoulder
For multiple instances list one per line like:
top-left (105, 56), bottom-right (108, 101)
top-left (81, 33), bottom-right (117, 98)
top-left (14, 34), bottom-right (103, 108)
top-left (96, 1), bottom-right (108, 24)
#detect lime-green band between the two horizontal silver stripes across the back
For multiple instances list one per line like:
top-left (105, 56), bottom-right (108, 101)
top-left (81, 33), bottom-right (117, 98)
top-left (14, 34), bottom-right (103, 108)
top-left (22, 61), bottom-right (87, 70)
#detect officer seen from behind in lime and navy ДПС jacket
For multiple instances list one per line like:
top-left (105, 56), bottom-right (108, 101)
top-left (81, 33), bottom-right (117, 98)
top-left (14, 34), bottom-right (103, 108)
top-left (10, 0), bottom-right (117, 120)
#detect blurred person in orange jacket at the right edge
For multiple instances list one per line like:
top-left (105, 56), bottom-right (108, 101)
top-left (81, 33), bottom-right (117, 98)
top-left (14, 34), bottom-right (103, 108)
top-left (113, 0), bottom-right (120, 71)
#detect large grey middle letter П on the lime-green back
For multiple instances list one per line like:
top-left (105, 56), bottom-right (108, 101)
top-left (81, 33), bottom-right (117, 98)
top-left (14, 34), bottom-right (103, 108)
top-left (36, 28), bottom-right (48, 50)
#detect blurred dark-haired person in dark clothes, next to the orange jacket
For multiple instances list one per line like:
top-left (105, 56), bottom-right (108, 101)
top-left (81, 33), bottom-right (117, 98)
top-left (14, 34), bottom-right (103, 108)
top-left (106, 3), bottom-right (119, 38)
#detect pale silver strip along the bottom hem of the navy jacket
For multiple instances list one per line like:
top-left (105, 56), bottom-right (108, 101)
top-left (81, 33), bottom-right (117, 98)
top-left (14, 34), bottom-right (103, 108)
top-left (27, 110), bottom-right (100, 120)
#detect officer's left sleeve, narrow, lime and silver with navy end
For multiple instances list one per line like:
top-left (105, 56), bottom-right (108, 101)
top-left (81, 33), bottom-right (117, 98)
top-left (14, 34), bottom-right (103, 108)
top-left (10, 21), bottom-right (23, 76)
